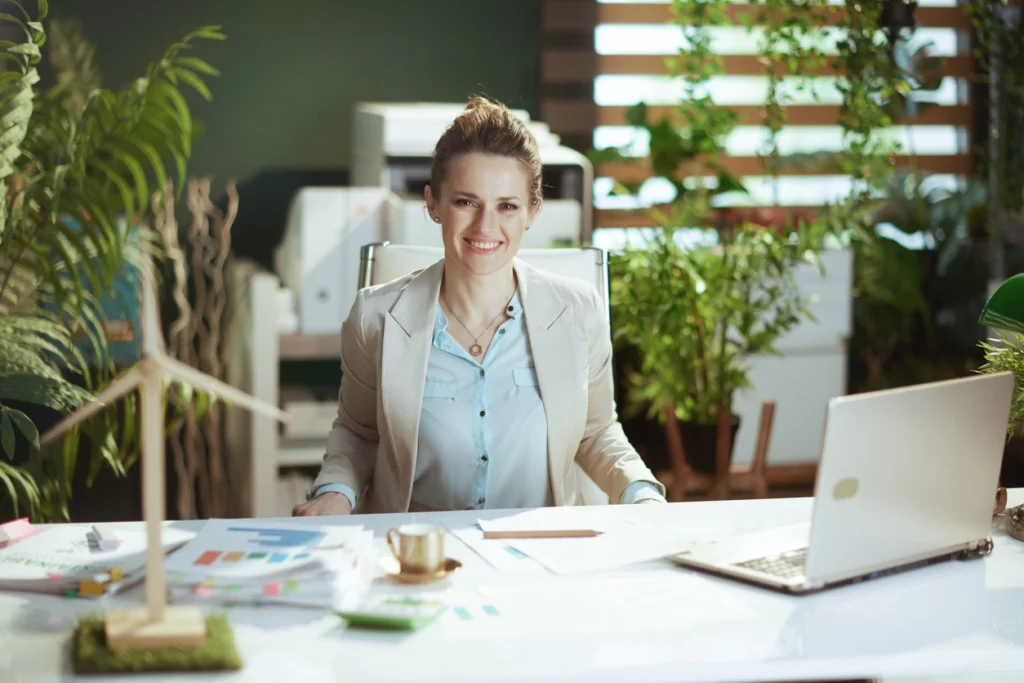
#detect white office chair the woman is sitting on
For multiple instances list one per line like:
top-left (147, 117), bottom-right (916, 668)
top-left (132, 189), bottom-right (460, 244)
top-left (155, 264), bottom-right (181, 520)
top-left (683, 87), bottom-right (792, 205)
top-left (358, 242), bottom-right (611, 505)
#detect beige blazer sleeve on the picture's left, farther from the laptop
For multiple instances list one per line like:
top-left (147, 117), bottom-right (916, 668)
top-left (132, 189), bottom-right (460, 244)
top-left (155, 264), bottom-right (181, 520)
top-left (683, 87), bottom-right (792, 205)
top-left (312, 291), bottom-right (380, 499)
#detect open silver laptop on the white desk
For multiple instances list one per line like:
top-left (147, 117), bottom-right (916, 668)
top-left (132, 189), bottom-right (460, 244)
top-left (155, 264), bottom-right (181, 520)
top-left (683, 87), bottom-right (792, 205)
top-left (669, 373), bottom-right (1014, 593)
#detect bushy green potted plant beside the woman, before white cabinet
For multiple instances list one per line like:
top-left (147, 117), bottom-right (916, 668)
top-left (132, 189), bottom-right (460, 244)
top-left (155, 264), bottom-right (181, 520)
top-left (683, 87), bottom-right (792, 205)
top-left (611, 184), bottom-right (827, 473)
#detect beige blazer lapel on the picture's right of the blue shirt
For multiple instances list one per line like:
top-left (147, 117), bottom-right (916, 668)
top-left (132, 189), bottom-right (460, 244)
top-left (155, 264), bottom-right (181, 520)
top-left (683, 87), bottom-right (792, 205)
top-left (515, 259), bottom-right (586, 506)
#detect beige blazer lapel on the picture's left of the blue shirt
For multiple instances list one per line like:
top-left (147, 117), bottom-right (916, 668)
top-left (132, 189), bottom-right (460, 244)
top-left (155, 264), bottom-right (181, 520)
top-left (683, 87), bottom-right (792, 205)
top-left (381, 261), bottom-right (444, 510)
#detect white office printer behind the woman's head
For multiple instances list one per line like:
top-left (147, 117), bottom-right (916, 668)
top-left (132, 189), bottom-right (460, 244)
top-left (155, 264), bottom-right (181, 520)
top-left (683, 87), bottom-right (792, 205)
top-left (351, 102), bottom-right (594, 248)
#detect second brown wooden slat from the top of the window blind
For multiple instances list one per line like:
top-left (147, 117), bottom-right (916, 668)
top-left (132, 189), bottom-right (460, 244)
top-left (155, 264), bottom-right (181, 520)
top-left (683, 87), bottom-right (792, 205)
top-left (593, 50), bottom-right (974, 82)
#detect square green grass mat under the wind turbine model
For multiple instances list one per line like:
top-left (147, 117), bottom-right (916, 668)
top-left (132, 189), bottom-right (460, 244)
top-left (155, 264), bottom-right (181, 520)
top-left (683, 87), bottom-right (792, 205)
top-left (72, 614), bottom-right (242, 674)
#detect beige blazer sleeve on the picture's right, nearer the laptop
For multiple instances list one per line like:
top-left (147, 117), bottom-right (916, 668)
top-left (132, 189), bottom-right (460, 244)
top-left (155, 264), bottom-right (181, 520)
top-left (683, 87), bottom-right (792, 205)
top-left (575, 288), bottom-right (666, 504)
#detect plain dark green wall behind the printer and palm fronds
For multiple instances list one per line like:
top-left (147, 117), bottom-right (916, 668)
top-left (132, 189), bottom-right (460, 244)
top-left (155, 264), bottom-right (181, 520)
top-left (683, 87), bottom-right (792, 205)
top-left (44, 0), bottom-right (541, 265)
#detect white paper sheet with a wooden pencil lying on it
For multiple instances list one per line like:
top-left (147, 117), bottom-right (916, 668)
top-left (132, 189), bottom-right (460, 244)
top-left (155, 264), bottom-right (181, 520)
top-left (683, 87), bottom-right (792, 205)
top-left (478, 509), bottom-right (711, 573)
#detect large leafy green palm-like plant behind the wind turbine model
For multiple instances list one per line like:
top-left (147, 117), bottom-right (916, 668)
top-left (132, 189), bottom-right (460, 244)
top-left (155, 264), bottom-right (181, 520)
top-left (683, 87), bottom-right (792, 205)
top-left (0, 0), bottom-right (223, 519)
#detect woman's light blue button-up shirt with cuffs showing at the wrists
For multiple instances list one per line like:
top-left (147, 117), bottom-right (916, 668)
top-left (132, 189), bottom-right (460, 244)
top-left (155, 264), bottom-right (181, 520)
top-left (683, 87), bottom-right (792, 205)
top-left (316, 291), bottom-right (664, 510)
